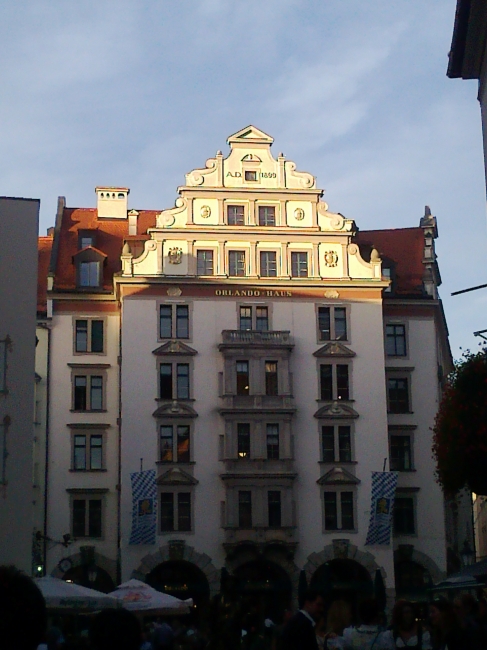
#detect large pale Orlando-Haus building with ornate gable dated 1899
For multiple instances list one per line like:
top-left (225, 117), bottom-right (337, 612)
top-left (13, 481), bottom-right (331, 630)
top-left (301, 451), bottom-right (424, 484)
top-left (44, 127), bottom-right (451, 615)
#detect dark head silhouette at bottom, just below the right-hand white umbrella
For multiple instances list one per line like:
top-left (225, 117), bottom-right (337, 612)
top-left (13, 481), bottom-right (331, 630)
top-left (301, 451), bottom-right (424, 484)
top-left (90, 609), bottom-right (142, 650)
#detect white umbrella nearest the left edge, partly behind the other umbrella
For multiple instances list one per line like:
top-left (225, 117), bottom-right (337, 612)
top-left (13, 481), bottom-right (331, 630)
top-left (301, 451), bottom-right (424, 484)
top-left (35, 576), bottom-right (120, 611)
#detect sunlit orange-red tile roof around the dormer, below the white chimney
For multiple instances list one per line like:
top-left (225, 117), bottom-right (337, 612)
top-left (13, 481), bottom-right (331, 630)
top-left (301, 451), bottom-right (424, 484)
top-left (54, 208), bottom-right (160, 290)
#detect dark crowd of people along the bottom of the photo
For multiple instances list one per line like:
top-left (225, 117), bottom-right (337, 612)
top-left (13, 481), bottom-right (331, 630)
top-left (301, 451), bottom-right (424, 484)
top-left (0, 567), bottom-right (487, 650)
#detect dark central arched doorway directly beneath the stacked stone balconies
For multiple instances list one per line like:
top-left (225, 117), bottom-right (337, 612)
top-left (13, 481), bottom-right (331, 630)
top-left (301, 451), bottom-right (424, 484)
top-left (233, 558), bottom-right (293, 623)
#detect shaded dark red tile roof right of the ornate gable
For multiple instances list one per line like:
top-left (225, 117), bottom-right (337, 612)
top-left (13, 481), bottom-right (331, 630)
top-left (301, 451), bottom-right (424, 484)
top-left (354, 227), bottom-right (424, 295)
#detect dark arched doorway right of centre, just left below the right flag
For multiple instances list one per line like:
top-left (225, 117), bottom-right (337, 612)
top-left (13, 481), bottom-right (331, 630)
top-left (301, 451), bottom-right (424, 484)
top-left (310, 559), bottom-right (374, 622)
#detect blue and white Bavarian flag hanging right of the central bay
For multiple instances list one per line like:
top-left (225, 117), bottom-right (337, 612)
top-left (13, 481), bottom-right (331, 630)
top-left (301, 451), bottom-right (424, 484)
top-left (365, 472), bottom-right (398, 546)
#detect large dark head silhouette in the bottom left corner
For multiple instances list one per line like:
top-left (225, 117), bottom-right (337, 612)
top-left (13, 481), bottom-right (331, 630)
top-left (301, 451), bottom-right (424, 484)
top-left (0, 566), bottom-right (47, 650)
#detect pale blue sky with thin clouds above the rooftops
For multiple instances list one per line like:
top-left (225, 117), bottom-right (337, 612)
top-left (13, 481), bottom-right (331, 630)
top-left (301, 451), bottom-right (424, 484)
top-left (0, 0), bottom-right (487, 356)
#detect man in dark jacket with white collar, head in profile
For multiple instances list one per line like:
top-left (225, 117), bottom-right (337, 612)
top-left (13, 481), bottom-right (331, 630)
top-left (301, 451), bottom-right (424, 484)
top-left (283, 589), bottom-right (325, 650)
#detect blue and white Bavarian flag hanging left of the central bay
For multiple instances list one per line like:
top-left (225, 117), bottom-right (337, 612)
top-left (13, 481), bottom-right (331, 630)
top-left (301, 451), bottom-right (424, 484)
top-left (129, 469), bottom-right (157, 544)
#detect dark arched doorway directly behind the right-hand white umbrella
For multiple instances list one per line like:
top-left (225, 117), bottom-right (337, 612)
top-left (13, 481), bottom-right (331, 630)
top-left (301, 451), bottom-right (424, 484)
top-left (146, 560), bottom-right (210, 614)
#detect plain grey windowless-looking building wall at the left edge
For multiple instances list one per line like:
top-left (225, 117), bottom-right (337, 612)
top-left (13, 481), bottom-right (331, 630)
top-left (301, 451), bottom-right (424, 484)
top-left (0, 197), bottom-right (39, 574)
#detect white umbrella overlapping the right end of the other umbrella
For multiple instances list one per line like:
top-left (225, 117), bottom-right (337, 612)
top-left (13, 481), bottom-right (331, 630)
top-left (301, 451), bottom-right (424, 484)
top-left (109, 579), bottom-right (193, 614)
